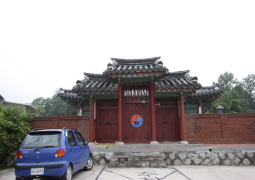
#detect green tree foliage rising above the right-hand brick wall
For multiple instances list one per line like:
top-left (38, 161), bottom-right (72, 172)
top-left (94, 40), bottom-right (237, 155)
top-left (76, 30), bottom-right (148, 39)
top-left (206, 72), bottom-right (255, 113)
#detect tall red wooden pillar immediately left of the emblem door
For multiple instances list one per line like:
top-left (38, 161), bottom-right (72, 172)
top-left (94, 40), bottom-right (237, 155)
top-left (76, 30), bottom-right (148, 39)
top-left (117, 80), bottom-right (124, 145)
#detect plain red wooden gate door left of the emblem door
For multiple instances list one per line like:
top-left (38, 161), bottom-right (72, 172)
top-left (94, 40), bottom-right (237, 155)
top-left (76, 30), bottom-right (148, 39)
top-left (96, 109), bottom-right (118, 143)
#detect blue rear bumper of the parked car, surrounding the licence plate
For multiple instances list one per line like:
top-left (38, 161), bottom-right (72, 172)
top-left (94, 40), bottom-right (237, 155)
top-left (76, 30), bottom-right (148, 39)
top-left (15, 161), bottom-right (68, 177)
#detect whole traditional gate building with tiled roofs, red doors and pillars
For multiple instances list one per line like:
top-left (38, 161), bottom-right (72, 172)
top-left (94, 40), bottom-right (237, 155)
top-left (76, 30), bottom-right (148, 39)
top-left (58, 57), bottom-right (223, 143)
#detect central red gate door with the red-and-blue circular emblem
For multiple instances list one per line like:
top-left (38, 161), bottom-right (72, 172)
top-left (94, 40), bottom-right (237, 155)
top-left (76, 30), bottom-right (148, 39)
top-left (123, 103), bottom-right (151, 143)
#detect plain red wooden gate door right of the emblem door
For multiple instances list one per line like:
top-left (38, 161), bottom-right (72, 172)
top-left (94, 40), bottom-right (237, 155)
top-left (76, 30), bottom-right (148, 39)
top-left (156, 108), bottom-right (180, 142)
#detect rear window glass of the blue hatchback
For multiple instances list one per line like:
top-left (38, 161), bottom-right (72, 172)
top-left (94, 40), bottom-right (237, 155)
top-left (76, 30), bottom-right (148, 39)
top-left (21, 132), bottom-right (60, 149)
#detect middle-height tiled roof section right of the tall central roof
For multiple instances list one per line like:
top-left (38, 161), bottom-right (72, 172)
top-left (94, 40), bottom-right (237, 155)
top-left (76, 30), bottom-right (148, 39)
top-left (155, 70), bottom-right (202, 90)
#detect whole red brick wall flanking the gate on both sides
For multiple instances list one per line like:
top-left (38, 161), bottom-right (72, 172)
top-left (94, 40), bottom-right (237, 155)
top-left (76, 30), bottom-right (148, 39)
top-left (30, 113), bottom-right (255, 144)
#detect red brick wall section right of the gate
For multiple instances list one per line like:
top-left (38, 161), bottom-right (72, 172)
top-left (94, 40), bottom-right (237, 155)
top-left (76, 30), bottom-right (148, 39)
top-left (185, 113), bottom-right (255, 144)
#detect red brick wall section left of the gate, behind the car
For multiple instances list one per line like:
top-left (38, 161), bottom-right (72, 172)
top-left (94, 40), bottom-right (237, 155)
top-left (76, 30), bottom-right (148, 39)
top-left (30, 116), bottom-right (89, 141)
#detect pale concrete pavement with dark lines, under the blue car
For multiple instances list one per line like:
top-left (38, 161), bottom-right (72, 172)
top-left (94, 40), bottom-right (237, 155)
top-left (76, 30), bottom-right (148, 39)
top-left (0, 165), bottom-right (255, 180)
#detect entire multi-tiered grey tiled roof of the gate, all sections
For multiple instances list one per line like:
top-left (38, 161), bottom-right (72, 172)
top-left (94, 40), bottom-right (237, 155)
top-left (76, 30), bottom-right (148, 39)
top-left (58, 57), bottom-right (224, 101)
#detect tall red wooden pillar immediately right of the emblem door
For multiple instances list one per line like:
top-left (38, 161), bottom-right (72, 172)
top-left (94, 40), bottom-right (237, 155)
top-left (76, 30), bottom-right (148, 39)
top-left (150, 81), bottom-right (158, 144)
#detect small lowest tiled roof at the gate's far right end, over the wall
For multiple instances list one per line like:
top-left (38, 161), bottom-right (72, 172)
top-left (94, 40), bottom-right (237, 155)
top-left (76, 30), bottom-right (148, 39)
top-left (192, 86), bottom-right (224, 98)
